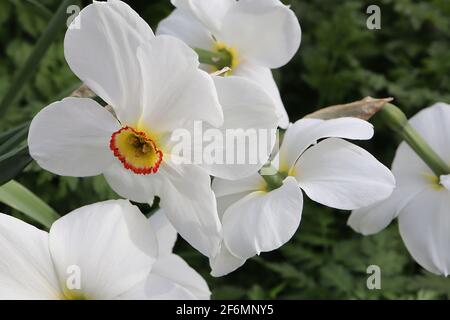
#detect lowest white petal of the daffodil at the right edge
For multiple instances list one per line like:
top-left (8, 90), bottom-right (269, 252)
top-left (398, 188), bottom-right (450, 276)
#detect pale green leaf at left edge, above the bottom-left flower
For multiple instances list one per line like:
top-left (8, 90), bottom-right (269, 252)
top-left (0, 180), bottom-right (60, 228)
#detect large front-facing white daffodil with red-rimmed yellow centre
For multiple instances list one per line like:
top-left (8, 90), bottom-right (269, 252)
top-left (28, 0), bottom-right (277, 256)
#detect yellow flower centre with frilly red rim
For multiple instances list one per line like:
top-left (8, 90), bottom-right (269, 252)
top-left (109, 127), bottom-right (163, 174)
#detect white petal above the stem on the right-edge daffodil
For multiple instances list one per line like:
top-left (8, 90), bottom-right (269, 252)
top-left (409, 102), bottom-right (450, 162)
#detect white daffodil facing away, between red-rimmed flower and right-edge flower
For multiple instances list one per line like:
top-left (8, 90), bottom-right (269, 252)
top-left (210, 118), bottom-right (395, 276)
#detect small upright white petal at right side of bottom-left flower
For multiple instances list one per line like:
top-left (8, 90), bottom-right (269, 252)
top-left (148, 209), bottom-right (177, 255)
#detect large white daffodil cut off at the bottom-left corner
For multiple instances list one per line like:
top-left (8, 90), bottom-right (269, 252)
top-left (0, 200), bottom-right (210, 300)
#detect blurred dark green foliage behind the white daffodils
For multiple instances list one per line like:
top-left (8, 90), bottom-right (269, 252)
top-left (0, 0), bottom-right (450, 299)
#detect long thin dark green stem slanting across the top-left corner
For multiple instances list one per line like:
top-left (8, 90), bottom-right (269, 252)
top-left (0, 0), bottom-right (78, 117)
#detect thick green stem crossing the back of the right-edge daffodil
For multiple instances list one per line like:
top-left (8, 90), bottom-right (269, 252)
top-left (380, 103), bottom-right (450, 177)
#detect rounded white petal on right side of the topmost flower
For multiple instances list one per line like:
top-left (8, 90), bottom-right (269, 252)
top-left (218, 0), bottom-right (301, 69)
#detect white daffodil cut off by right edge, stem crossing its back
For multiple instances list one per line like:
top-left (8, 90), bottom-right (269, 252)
top-left (348, 103), bottom-right (450, 276)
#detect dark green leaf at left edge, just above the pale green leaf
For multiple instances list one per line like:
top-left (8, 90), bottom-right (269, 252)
top-left (0, 146), bottom-right (33, 186)
